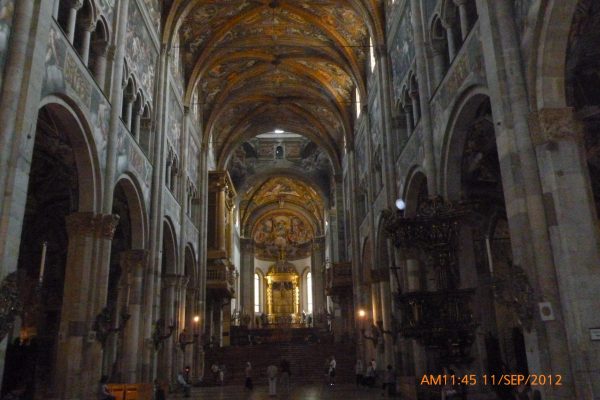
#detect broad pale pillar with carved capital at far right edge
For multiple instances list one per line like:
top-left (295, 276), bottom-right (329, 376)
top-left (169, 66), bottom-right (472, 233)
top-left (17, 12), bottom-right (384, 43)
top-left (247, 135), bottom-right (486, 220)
top-left (529, 107), bottom-right (600, 398)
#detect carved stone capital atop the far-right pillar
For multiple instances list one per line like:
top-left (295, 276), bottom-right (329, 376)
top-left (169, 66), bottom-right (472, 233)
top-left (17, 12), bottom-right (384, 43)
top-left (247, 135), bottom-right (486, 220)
top-left (529, 107), bottom-right (584, 145)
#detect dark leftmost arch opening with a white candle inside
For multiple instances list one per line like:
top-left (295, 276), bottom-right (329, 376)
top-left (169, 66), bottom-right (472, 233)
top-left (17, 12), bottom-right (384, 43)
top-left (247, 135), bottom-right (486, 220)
top-left (2, 99), bottom-right (97, 399)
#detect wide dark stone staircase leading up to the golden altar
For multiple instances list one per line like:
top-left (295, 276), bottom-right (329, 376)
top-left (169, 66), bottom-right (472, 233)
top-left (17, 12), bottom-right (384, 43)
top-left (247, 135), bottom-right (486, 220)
top-left (204, 343), bottom-right (356, 385)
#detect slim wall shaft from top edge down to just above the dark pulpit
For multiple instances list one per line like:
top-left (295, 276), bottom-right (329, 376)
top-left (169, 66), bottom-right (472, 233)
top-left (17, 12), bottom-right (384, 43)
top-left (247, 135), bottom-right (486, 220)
top-left (410, 0), bottom-right (438, 196)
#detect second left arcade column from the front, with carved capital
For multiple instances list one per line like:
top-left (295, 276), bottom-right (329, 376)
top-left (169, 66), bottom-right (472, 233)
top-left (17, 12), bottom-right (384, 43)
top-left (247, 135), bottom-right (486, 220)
top-left (121, 250), bottom-right (148, 383)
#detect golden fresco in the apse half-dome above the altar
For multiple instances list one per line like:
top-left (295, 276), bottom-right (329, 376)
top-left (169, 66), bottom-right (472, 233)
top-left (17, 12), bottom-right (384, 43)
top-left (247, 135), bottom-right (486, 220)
top-left (252, 211), bottom-right (314, 260)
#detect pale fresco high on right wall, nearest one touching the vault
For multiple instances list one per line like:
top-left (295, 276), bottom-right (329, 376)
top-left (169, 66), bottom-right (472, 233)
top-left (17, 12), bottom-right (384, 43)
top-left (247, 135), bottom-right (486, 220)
top-left (391, 2), bottom-right (415, 100)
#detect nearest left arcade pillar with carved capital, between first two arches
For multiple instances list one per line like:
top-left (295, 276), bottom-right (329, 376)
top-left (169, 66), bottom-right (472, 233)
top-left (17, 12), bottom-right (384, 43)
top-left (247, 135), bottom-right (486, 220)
top-left (54, 212), bottom-right (118, 399)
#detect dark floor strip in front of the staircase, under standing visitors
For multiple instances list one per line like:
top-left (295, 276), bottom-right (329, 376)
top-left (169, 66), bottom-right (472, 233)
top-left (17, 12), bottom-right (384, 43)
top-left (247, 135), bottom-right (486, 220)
top-left (175, 384), bottom-right (394, 400)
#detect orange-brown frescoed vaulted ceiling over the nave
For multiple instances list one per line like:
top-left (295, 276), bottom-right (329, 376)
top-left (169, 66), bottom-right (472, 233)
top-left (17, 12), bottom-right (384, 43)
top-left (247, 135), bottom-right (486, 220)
top-left (165, 0), bottom-right (383, 166)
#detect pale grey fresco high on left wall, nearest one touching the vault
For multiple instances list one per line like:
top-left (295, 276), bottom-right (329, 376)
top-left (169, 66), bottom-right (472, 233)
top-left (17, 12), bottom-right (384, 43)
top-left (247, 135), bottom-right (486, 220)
top-left (125, 2), bottom-right (158, 100)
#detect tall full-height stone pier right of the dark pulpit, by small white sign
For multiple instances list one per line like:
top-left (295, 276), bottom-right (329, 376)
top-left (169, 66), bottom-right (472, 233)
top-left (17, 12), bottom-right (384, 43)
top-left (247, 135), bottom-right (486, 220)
top-left (477, 0), bottom-right (589, 399)
